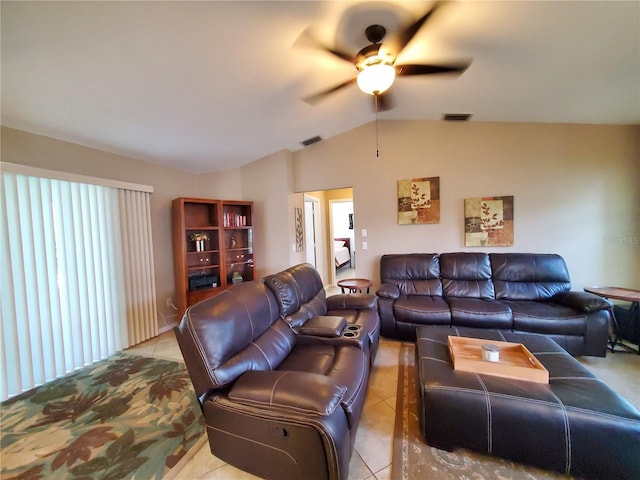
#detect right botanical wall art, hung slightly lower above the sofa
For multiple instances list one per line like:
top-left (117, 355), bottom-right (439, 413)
top-left (464, 196), bottom-right (513, 247)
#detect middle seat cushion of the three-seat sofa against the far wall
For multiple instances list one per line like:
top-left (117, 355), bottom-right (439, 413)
top-left (446, 297), bottom-right (513, 330)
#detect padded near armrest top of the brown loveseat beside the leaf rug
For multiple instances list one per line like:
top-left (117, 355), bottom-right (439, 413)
top-left (229, 371), bottom-right (347, 415)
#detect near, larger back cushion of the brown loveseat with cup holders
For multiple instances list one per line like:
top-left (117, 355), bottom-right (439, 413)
top-left (174, 282), bottom-right (295, 397)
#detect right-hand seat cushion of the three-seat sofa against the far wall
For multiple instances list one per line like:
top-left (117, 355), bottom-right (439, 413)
top-left (502, 300), bottom-right (587, 336)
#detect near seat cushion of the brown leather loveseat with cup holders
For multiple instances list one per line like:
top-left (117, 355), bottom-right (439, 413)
top-left (278, 344), bottom-right (369, 428)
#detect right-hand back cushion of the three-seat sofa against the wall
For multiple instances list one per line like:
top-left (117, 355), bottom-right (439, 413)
top-left (489, 253), bottom-right (571, 300)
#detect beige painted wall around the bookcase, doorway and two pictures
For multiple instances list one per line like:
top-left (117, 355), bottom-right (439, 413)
top-left (1, 121), bottom-right (640, 334)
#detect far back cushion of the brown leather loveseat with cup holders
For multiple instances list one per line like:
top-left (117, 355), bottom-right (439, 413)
top-left (263, 263), bottom-right (327, 329)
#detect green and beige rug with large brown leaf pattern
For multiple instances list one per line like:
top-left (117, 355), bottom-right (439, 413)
top-left (0, 353), bottom-right (204, 480)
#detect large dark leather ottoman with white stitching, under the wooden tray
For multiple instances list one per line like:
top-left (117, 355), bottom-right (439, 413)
top-left (416, 326), bottom-right (640, 479)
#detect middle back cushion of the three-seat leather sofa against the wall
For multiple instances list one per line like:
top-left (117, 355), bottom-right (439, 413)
top-left (440, 252), bottom-right (495, 300)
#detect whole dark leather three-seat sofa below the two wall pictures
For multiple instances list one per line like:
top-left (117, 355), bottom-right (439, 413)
top-left (377, 252), bottom-right (612, 357)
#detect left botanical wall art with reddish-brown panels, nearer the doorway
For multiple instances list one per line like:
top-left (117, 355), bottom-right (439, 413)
top-left (398, 177), bottom-right (440, 225)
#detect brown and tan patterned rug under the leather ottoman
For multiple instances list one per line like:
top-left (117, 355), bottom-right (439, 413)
top-left (391, 343), bottom-right (571, 480)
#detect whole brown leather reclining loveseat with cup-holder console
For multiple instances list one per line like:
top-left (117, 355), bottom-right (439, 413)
top-left (174, 266), bottom-right (379, 479)
